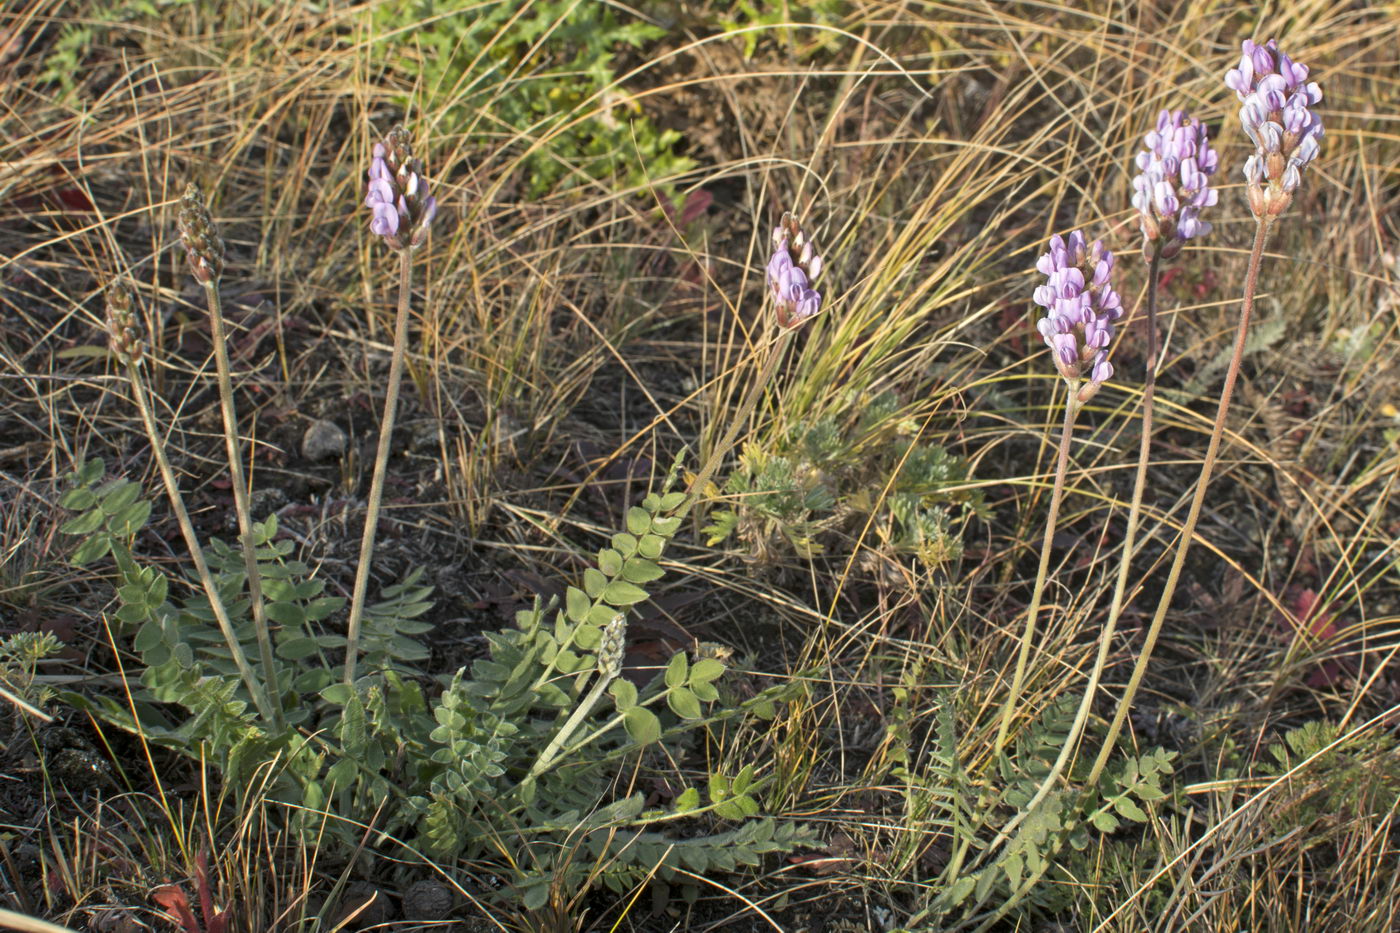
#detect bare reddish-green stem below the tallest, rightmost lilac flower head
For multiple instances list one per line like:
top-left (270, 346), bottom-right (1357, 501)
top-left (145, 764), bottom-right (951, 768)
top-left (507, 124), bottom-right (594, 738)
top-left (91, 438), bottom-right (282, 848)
top-left (1089, 217), bottom-right (1273, 786)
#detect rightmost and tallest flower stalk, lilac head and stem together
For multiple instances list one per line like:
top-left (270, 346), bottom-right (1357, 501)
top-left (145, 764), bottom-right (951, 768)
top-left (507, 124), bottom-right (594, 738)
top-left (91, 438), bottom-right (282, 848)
top-left (1089, 39), bottom-right (1322, 783)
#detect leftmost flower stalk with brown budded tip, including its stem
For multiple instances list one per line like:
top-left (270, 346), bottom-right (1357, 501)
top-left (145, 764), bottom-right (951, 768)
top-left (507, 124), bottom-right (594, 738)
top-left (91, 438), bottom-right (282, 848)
top-left (106, 280), bottom-right (273, 720)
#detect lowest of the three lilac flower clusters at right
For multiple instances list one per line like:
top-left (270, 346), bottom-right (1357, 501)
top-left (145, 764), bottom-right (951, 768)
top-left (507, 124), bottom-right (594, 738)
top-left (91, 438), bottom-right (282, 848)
top-left (1033, 231), bottom-right (1123, 403)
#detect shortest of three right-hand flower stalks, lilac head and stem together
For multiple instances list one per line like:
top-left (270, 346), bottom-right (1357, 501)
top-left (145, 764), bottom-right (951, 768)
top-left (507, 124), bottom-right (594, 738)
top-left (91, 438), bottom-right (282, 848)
top-left (995, 231), bottom-right (1123, 749)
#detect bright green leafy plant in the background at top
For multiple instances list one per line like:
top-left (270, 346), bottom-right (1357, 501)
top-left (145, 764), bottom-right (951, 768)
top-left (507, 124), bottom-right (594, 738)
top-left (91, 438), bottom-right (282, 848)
top-left (371, 0), bottom-right (694, 196)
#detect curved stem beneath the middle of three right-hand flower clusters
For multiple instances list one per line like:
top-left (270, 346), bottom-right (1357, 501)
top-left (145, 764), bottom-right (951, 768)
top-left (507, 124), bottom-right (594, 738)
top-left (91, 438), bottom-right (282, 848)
top-left (1001, 251), bottom-right (1161, 835)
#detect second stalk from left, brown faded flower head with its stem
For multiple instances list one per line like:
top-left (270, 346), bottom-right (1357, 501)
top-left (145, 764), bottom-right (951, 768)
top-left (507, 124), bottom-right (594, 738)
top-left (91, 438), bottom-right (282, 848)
top-left (175, 182), bottom-right (283, 726)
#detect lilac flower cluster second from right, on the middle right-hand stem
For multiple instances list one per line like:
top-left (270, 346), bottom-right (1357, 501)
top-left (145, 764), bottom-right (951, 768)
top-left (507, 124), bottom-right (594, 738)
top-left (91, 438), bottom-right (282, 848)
top-left (1133, 111), bottom-right (1219, 261)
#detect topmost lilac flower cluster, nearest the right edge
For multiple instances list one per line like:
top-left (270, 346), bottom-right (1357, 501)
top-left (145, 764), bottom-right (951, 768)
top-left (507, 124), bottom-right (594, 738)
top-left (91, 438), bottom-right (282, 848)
top-left (1225, 39), bottom-right (1322, 217)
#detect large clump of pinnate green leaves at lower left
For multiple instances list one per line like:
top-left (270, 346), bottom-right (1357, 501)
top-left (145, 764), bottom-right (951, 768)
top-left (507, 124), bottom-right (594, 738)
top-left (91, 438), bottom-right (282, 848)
top-left (63, 461), bottom-right (811, 909)
